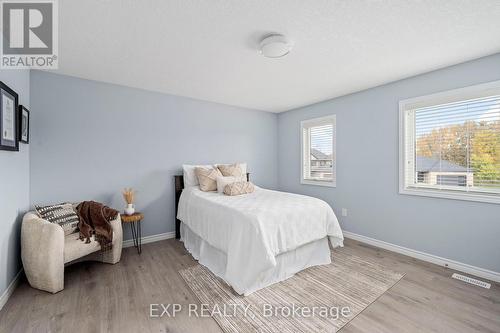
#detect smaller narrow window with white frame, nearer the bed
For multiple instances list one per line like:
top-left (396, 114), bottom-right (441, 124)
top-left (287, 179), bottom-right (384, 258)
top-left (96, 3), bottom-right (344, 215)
top-left (301, 115), bottom-right (336, 186)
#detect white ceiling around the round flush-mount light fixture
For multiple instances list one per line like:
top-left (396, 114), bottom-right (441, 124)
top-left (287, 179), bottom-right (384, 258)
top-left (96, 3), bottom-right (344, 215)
top-left (57, 0), bottom-right (500, 112)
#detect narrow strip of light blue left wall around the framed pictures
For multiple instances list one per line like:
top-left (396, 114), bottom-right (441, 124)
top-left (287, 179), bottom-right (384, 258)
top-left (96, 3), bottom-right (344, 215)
top-left (0, 70), bottom-right (30, 295)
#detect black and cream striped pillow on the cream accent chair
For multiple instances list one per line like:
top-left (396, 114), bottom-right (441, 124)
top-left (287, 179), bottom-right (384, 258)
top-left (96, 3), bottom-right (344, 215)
top-left (35, 203), bottom-right (80, 235)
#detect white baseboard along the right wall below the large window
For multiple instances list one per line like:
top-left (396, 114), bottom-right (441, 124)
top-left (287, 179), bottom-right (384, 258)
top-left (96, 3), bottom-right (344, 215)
top-left (343, 231), bottom-right (500, 282)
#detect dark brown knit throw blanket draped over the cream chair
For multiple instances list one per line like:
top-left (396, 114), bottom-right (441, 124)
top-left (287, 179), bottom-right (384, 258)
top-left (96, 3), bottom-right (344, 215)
top-left (76, 201), bottom-right (118, 251)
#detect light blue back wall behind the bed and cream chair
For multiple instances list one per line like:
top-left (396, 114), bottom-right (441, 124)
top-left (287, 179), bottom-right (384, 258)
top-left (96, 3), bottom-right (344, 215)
top-left (31, 71), bottom-right (277, 240)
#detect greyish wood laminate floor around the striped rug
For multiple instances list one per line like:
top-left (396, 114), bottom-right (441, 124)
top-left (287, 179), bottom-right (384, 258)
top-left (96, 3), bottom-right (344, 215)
top-left (0, 239), bottom-right (500, 333)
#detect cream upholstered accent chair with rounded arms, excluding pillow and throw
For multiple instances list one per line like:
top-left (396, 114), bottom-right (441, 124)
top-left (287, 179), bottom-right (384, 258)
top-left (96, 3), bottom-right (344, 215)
top-left (21, 212), bottom-right (123, 293)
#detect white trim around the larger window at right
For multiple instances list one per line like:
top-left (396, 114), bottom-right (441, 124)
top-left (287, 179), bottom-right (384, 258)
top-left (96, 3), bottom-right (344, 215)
top-left (399, 80), bottom-right (500, 204)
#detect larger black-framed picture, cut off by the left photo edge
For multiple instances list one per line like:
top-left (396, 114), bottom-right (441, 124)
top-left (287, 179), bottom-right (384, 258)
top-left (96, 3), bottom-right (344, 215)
top-left (0, 81), bottom-right (19, 151)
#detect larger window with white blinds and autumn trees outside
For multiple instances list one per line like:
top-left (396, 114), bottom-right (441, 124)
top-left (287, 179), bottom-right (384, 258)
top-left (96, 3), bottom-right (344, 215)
top-left (399, 81), bottom-right (500, 203)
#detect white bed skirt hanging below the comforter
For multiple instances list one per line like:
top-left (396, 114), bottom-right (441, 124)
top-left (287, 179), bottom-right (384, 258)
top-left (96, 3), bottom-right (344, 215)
top-left (180, 223), bottom-right (331, 296)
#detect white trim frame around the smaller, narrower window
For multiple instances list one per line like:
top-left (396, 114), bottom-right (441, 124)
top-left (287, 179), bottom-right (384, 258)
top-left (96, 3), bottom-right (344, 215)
top-left (300, 114), bottom-right (337, 187)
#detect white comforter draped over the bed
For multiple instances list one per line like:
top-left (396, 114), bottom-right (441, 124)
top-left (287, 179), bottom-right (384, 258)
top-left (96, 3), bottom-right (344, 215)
top-left (177, 187), bottom-right (344, 294)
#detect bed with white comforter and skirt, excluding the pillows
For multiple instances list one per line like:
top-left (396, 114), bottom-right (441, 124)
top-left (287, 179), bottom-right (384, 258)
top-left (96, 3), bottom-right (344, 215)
top-left (175, 174), bottom-right (343, 296)
